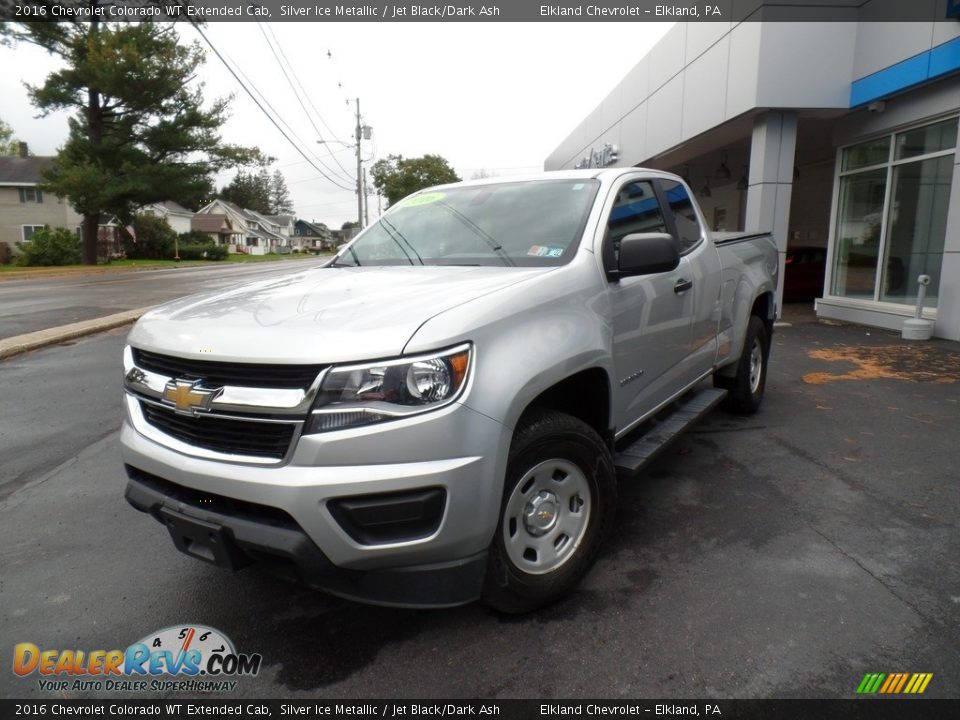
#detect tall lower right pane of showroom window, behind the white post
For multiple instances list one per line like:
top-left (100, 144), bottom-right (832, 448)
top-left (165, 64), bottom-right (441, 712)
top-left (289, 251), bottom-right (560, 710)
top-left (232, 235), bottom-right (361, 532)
top-left (880, 155), bottom-right (956, 307)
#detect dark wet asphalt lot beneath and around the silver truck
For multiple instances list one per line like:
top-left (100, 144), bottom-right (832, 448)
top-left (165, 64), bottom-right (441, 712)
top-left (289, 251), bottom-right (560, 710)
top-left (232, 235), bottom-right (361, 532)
top-left (0, 306), bottom-right (960, 698)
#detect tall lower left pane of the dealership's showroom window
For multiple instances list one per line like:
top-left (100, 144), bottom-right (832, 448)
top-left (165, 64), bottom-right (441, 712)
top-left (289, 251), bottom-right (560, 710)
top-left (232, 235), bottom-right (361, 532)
top-left (832, 168), bottom-right (887, 300)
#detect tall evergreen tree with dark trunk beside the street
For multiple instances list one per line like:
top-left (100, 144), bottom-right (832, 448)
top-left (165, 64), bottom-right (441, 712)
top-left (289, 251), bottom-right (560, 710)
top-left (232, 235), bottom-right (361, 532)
top-left (2, 7), bottom-right (261, 264)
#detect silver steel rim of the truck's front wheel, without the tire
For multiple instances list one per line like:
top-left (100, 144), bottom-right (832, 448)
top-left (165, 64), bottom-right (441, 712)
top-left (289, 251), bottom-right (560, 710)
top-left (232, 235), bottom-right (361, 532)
top-left (503, 458), bottom-right (592, 575)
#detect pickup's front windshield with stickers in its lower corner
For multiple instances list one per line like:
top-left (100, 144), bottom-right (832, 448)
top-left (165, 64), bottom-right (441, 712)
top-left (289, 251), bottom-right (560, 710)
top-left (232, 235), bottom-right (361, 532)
top-left (333, 179), bottom-right (599, 267)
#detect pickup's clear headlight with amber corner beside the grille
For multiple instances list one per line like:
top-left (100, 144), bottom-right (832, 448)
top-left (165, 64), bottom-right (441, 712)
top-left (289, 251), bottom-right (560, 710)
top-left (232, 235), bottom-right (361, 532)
top-left (304, 345), bottom-right (470, 434)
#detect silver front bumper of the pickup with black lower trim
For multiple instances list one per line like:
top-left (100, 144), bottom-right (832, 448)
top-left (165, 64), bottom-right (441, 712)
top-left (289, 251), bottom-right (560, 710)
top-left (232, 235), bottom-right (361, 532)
top-left (121, 396), bottom-right (510, 606)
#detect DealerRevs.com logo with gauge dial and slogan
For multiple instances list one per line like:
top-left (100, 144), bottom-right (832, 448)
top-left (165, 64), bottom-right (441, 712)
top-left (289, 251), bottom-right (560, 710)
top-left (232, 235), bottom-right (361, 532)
top-left (13, 625), bottom-right (263, 692)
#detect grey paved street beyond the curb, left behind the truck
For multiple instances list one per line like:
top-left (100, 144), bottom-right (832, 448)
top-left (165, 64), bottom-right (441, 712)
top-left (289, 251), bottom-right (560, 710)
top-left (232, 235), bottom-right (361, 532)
top-left (0, 258), bottom-right (327, 339)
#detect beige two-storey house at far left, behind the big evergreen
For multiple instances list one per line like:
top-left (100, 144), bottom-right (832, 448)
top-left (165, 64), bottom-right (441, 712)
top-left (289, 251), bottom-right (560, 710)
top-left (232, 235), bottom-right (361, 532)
top-left (0, 148), bottom-right (83, 256)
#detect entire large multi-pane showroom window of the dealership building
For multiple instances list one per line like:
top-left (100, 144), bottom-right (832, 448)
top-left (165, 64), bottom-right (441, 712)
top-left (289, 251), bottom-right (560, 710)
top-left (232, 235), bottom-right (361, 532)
top-left (831, 118), bottom-right (957, 306)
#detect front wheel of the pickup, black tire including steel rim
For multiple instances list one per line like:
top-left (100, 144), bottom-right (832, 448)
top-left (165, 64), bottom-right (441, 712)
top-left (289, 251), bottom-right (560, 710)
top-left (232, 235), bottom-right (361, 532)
top-left (483, 410), bottom-right (617, 614)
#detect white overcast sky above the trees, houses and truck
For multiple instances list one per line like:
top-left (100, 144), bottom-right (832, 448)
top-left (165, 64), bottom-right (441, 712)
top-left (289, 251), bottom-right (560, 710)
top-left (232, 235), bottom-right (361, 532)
top-left (0, 22), bottom-right (671, 227)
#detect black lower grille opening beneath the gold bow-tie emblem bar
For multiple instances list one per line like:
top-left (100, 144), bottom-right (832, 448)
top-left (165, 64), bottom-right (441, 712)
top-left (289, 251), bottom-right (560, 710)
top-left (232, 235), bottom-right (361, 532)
top-left (140, 402), bottom-right (296, 460)
